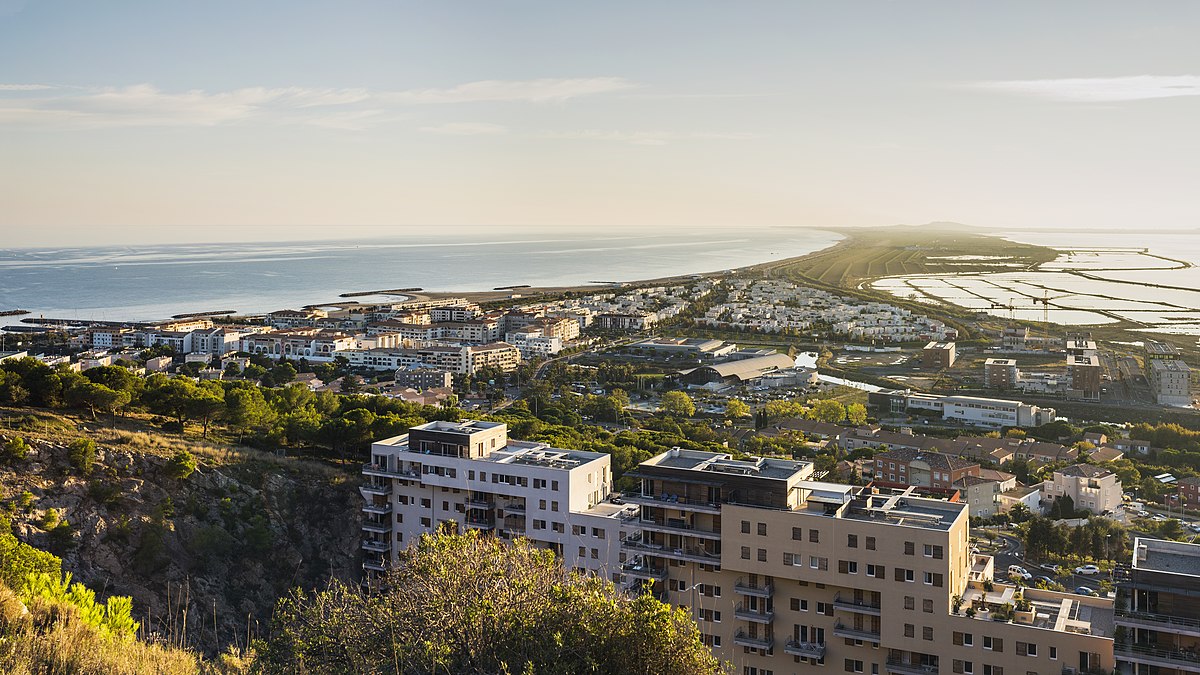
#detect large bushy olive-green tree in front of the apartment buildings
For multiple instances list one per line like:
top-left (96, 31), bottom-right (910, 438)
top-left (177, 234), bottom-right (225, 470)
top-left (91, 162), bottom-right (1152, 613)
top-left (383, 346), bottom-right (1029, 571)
top-left (259, 531), bottom-right (721, 675)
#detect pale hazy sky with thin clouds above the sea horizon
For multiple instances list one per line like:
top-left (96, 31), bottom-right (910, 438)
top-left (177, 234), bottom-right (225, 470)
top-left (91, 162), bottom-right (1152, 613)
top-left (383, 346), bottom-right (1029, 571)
top-left (0, 0), bottom-right (1200, 246)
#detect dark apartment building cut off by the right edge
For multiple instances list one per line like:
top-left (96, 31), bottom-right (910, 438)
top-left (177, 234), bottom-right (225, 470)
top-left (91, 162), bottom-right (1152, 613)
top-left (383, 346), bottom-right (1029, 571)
top-left (1116, 537), bottom-right (1200, 675)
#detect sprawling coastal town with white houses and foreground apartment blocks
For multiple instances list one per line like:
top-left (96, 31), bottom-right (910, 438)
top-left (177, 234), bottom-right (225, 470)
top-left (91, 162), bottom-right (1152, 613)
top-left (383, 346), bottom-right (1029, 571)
top-left (0, 265), bottom-right (1200, 674)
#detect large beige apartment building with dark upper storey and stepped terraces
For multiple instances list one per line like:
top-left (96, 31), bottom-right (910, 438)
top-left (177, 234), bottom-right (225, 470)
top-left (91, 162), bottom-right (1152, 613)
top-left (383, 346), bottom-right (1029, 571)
top-left (623, 449), bottom-right (1114, 675)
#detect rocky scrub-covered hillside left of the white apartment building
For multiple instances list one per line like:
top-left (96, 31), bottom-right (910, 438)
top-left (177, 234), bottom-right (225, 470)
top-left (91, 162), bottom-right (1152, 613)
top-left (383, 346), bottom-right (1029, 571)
top-left (0, 408), bottom-right (359, 655)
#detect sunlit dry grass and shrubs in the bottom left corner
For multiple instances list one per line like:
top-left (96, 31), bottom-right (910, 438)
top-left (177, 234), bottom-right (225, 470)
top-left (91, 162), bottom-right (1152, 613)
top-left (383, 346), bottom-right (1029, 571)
top-left (0, 585), bottom-right (246, 675)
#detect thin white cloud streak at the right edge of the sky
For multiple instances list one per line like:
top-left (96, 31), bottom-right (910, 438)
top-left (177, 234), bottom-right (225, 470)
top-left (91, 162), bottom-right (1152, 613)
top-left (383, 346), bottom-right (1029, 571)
top-left (967, 74), bottom-right (1200, 103)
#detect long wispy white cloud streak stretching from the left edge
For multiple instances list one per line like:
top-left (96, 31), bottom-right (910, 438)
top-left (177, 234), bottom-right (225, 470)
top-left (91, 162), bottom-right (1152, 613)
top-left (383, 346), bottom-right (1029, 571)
top-left (0, 77), bottom-right (635, 128)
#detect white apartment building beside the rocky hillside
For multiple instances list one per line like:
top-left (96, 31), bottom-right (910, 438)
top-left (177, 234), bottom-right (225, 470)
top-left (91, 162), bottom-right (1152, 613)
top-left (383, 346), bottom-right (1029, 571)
top-left (360, 420), bottom-right (637, 571)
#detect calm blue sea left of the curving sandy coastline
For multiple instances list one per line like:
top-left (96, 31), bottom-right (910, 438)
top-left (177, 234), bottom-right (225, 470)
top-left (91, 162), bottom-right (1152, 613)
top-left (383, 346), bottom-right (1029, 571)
top-left (0, 228), bottom-right (839, 325)
